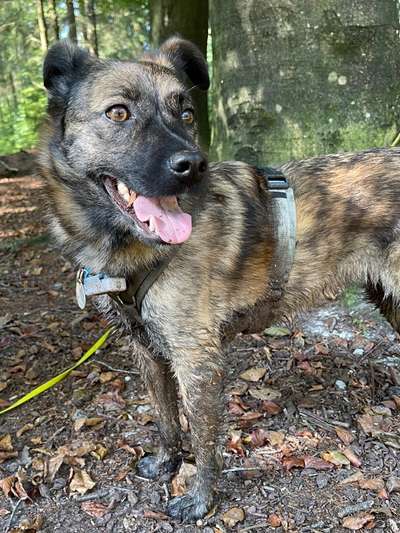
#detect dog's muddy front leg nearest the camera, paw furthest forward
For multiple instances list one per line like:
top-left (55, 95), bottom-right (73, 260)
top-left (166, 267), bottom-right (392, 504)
top-left (168, 354), bottom-right (224, 521)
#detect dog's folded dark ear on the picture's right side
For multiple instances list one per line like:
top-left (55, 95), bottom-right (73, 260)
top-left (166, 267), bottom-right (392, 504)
top-left (160, 37), bottom-right (210, 91)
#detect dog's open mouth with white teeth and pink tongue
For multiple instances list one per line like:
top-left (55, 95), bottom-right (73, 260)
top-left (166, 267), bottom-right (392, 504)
top-left (104, 176), bottom-right (192, 244)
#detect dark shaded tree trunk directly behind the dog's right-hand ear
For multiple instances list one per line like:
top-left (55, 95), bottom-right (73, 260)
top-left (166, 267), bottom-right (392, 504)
top-left (150, 0), bottom-right (210, 150)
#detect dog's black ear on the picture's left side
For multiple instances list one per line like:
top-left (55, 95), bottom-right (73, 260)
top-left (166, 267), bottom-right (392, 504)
top-left (43, 40), bottom-right (93, 98)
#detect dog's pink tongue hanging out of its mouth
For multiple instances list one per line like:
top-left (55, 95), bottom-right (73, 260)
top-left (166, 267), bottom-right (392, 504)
top-left (133, 196), bottom-right (192, 244)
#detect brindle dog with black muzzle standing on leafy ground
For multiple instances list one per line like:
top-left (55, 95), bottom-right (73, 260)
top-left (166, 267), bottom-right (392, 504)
top-left (39, 38), bottom-right (400, 520)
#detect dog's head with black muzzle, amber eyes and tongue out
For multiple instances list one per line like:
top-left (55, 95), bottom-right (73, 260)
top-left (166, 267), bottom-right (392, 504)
top-left (40, 37), bottom-right (209, 258)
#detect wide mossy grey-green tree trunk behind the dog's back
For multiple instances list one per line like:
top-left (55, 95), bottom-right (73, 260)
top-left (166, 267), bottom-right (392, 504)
top-left (211, 0), bottom-right (400, 164)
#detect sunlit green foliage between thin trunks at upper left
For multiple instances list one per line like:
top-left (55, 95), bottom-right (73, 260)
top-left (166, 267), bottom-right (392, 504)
top-left (0, 0), bottom-right (150, 155)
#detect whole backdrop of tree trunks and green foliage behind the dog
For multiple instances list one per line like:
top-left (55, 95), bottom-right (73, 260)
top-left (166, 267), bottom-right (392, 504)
top-left (0, 0), bottom-right (400, 164)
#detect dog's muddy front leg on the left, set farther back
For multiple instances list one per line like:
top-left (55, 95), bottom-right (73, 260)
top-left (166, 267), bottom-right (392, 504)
top-left (136, 347), bottom-right (181, 479)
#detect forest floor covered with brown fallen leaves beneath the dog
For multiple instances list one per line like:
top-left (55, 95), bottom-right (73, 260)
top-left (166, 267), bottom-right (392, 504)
top-left (0, 164), bottom-right (400, 533)
